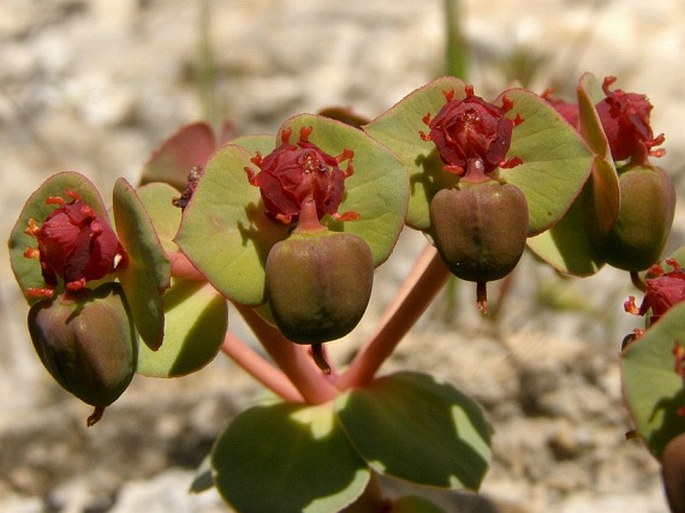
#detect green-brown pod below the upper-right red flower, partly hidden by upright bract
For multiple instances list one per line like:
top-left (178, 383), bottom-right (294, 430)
top-left (589, 167), bottom-right (675, 271)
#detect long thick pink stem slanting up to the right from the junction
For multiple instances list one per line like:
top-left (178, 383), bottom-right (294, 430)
top-left (336, 246), bottom-right (449, 390)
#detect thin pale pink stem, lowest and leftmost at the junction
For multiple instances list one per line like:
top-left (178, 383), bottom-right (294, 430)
top-left (221, 332), bottom-right (304, 402)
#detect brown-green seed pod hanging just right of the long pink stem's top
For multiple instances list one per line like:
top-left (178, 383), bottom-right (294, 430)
top-left (430, 182), bottom-right (528, 283)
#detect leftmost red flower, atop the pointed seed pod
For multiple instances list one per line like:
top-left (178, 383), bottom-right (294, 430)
top-left (26, 191), bottom-right (123, 296)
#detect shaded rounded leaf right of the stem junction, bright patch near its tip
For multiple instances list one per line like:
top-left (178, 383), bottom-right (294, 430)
top-left (336, 372), bottom-right (490, 490)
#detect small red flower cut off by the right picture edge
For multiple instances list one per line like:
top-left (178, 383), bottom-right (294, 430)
top-left (624, 259), bottom-right (685, 324)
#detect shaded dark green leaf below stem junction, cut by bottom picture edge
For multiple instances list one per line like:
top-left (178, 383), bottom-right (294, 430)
top-left (212, 402), bottom-right (370, 513)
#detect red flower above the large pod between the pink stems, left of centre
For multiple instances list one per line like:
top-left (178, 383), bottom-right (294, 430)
top-left (245, 127), bottom-right (359, 224)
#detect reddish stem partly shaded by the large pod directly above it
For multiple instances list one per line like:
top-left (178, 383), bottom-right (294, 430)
top-left (234, 303), bottom-right (338, 404)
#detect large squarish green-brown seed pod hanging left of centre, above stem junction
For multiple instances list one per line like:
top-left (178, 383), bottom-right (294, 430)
top-left (266, 230), bottom-right (374, 344)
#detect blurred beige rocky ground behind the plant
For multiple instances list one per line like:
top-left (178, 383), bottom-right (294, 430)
top-left (0, 0), bottom-right (685, 513)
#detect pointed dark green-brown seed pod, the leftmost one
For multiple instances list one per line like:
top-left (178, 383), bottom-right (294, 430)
top-left (28, 283), bottom-right (138, 421)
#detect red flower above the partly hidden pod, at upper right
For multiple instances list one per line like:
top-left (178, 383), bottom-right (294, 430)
top-left (595, 76), bottom-right (665, 164)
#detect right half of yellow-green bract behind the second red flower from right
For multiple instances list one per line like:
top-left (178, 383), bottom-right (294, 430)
top-left (500, 89), bottom-right (593, 235)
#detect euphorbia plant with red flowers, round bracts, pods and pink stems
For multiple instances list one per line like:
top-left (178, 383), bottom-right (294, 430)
top-left (10, 75), bottom-right (685, 513)
